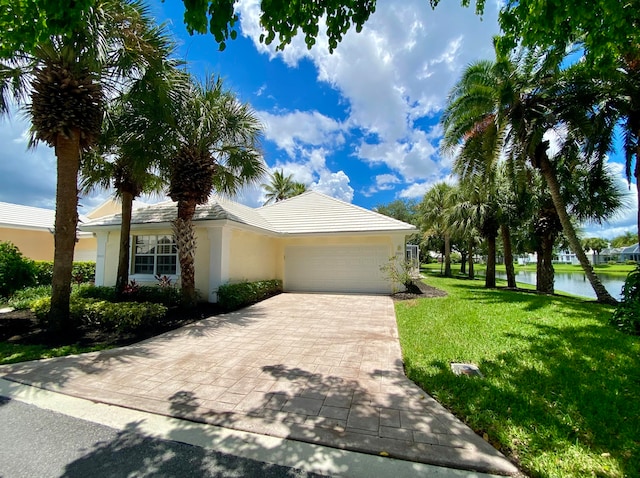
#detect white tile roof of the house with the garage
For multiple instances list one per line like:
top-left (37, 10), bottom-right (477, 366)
top-left (83, 191), bottom-right (416, 234)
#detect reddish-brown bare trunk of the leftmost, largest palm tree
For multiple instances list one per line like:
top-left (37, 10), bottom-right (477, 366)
top-left (49, 131), bottom-right (80, 335)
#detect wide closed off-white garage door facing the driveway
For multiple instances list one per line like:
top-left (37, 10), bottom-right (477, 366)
top-left (284, 246), bottom-right (391, 294)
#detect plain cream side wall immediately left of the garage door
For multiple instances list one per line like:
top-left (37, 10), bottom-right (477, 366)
top-left (229, 229), bottom-right (282, 282)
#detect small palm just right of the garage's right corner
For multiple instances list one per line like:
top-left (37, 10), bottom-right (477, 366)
top-left (418, 182), bottom-right (455, 277)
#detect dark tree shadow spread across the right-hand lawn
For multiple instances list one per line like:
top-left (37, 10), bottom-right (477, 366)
top-left (406, 316), bottom-right (640, 476)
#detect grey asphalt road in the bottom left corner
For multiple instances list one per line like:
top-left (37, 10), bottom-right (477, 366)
top-left (0, 397), bottom-right (328, 478)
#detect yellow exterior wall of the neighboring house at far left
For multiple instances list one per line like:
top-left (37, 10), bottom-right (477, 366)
top-left (0, 227), bottom-right (97, 261)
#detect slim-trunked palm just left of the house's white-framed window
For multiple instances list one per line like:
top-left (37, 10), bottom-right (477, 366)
top-left (81, 35), bottom-right (188, 294)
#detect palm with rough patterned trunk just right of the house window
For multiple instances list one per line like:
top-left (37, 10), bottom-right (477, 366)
top-left (168, 79), bottom-right (265, 306)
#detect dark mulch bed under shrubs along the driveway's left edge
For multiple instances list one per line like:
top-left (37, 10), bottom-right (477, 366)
top-left (0, 303), bottom-right (224, 347)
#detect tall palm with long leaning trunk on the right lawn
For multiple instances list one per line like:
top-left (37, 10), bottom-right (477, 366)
top-left (443, 46), bottom-right (616, 303)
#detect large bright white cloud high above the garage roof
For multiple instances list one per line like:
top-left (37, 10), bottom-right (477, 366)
top-left (236, 0), bottom-right (498, 184)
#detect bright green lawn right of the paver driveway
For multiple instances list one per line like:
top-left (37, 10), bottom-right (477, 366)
top-left (396, 277), bottom-right (640, 477)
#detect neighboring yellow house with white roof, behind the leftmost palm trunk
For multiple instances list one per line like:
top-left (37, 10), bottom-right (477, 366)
top-left (0, 202), bottom-right (97, 261)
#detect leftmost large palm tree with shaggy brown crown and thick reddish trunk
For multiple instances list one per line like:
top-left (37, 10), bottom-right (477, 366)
top-left (0, 0), bottom-right (168, 333)
